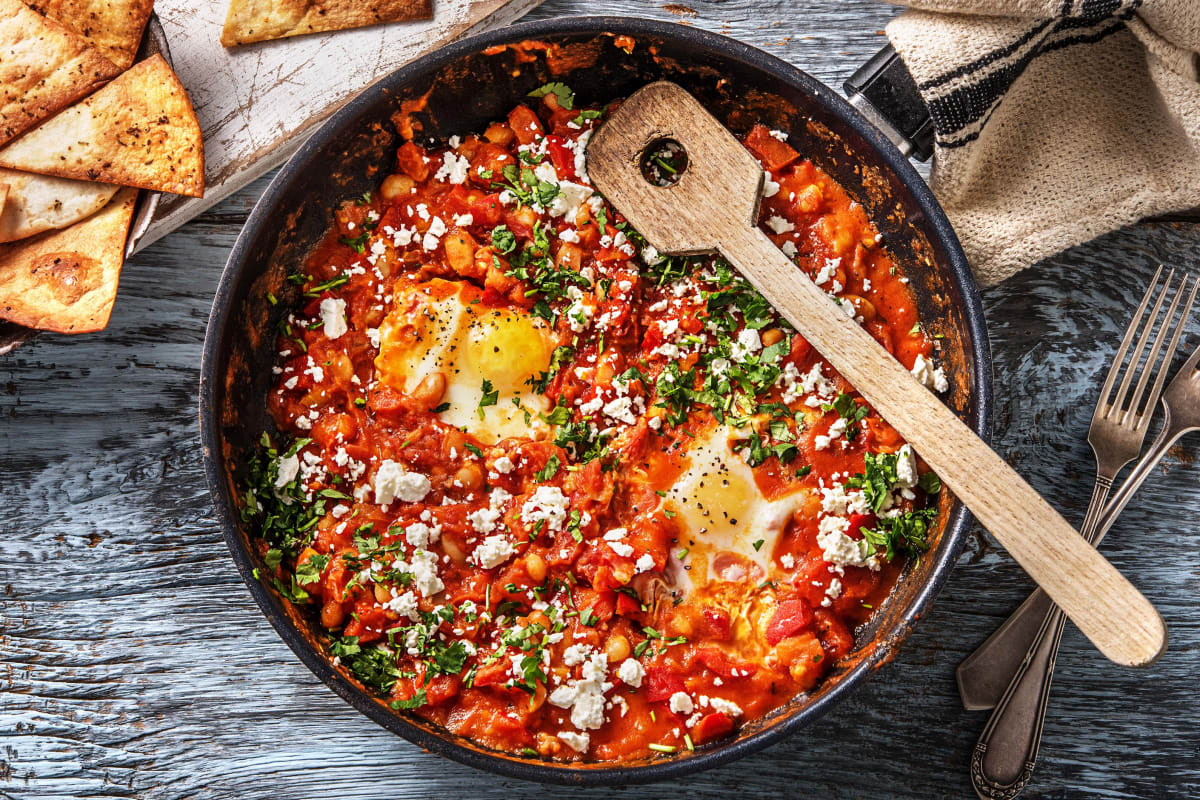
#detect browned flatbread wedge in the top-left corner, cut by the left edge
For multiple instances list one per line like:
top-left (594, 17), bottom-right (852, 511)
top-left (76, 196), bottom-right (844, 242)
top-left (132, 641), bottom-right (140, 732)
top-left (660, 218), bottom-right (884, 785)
top-left (0, 0), bottom-right (121, 146)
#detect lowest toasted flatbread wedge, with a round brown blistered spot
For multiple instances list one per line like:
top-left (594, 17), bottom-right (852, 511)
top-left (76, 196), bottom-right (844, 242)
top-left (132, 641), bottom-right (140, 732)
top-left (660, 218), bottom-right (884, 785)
top-left (0, 188), bottom-right (138, 333)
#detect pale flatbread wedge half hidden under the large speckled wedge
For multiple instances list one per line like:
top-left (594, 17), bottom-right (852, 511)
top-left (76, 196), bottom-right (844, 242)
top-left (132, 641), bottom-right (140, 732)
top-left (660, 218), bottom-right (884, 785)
top-left (0, 169), bottom-right (120, 242)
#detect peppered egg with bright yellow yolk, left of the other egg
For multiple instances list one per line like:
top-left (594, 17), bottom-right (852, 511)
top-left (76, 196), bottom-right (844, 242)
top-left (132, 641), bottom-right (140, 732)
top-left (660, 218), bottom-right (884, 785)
top-left (376, 279), bottom-right (557, 444)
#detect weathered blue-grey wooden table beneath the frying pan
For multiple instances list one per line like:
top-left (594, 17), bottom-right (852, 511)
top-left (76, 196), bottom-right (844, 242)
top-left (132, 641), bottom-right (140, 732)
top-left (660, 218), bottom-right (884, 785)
top-left (0, 0), bottom-right (1200, 800)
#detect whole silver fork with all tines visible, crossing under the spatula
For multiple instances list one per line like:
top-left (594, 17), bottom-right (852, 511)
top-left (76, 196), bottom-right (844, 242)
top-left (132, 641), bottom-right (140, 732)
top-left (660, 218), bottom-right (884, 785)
top-left (960, 267), bottom-right (1200, 800)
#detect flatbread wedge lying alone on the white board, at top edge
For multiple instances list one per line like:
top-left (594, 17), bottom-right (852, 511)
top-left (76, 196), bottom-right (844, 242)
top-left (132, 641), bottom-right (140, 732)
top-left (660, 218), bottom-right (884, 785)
top-left (221, 0), bottom-right (433, 47)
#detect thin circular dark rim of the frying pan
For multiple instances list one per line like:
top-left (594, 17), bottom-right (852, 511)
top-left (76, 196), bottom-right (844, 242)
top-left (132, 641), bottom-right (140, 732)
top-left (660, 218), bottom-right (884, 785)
top-left (199, 16), bottom-right (992, 786)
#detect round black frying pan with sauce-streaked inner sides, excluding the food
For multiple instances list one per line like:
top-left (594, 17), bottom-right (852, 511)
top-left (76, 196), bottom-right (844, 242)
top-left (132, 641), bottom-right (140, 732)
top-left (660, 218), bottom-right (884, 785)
top-left (200, 17), bottom-right (991, 784)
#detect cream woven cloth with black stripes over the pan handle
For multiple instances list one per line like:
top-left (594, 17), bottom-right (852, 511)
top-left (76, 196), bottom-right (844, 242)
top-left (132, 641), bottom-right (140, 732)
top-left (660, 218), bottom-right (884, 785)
top-left (887, 0), bottom-right (1200, 285)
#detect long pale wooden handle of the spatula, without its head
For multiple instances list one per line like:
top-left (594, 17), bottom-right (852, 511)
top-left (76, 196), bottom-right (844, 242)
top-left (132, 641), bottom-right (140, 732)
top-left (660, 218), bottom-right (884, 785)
top-left (719, 228), bottom-right (1166, 667)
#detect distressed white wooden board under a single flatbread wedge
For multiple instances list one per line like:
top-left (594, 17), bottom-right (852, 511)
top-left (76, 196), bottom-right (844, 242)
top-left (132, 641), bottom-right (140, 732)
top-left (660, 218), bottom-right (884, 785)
top-left (134, 0), bottom-right (541, 251)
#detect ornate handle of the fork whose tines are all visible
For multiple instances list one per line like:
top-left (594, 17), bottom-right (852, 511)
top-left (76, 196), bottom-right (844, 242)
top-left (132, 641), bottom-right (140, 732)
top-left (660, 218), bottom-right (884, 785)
top-left (971, 476), bottom-right (1112, 800)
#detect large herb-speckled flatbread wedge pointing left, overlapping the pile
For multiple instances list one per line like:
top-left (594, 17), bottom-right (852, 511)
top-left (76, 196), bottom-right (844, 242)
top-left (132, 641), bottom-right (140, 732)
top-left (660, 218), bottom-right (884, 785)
top-left (0, 55), bottom-right (204, 197)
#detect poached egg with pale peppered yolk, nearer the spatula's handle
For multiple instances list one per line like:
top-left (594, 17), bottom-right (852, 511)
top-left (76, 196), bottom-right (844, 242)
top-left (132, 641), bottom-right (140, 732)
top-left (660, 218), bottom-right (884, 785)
top-left (664, 425), bottom-right (809, 594)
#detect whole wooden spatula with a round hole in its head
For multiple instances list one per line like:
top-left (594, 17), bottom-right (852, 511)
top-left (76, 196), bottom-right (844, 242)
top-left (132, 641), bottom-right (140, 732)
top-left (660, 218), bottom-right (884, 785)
top-left (587, 82), bottom-right (1166, 666)
